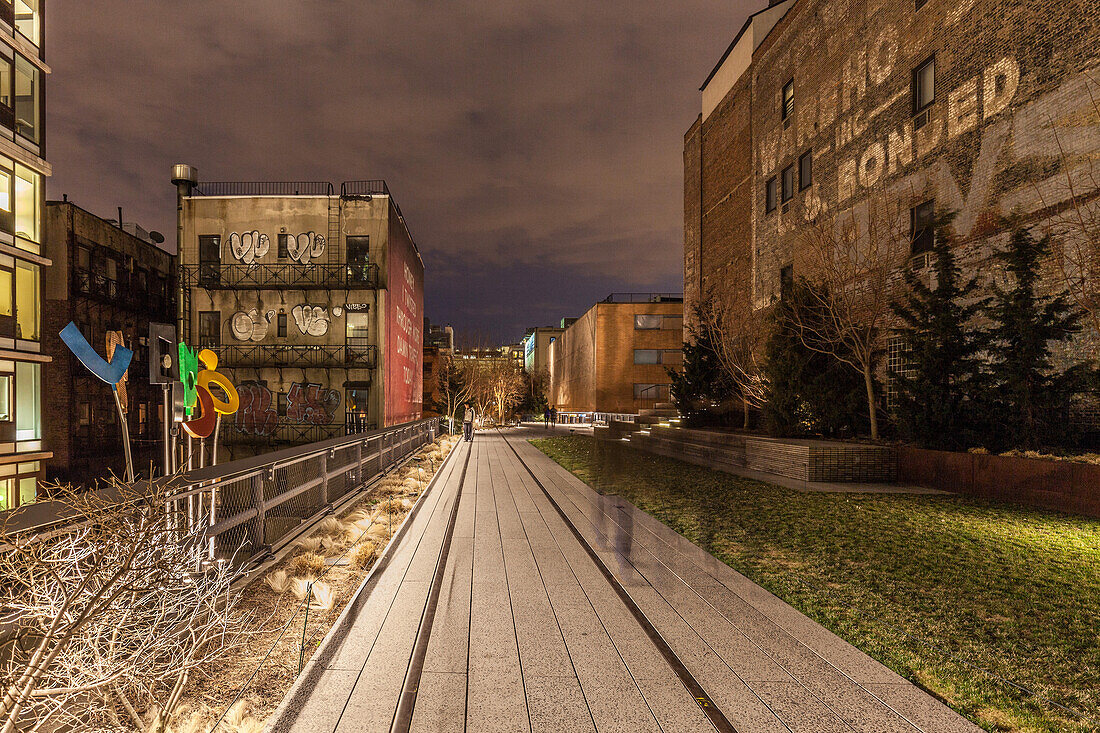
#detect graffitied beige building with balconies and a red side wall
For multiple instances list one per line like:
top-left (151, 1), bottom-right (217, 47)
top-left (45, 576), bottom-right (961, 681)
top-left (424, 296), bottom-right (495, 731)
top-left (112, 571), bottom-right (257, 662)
top-left (174, 171), bottom-right (424, 455)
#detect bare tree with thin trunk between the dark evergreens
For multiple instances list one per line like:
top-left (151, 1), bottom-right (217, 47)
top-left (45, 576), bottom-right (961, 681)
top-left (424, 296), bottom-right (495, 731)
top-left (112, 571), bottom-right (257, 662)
top-left (794, 193), bottom-right (911, 440)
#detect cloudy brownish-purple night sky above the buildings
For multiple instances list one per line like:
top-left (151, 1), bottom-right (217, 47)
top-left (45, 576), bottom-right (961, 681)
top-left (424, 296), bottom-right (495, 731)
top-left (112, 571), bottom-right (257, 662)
top-left (46, 0), bottom-right (766, 343)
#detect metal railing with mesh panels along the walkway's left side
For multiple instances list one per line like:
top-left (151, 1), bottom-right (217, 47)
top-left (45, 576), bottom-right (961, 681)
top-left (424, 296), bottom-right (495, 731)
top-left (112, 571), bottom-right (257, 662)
top-left (0, 418), bottom-right (439, 562)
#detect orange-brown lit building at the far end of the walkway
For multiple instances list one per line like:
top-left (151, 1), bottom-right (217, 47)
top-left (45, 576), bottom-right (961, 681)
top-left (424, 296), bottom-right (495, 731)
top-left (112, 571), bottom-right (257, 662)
top-left (547, 293), bottom-right (683, 414)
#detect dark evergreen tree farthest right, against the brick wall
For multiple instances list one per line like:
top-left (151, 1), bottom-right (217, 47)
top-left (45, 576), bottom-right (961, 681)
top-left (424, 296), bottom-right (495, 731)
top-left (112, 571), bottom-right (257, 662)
top-left (986, 222), bottom-right (1088, 449)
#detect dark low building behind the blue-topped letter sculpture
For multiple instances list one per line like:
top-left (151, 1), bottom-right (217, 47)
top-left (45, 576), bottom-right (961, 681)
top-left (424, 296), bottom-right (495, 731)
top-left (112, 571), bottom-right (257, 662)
top-left (42, 201), bottom-right (176, 486)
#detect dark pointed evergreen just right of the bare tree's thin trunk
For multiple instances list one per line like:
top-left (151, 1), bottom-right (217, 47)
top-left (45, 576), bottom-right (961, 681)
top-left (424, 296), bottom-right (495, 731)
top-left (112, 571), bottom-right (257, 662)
top-left (891, 217), bottom-right (983, 450)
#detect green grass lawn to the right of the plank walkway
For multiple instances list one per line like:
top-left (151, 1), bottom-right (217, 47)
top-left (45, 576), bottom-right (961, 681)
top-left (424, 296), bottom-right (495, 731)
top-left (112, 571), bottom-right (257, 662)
top-left (532, 437), bottom-right (1100, 731)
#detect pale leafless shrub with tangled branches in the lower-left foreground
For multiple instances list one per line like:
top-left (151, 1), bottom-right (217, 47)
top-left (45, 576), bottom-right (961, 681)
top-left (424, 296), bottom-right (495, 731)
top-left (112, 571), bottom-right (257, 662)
top-left (0, 482), bottom-right (249, 733)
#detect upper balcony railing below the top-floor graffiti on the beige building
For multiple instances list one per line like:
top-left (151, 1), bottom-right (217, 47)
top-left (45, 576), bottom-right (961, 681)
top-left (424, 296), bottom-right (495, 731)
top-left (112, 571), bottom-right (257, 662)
top-left (182, 263), bottom-right (378, 291)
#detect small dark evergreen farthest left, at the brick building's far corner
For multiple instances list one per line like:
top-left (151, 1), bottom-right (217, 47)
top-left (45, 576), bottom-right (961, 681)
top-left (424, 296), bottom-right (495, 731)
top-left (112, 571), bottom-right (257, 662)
top-left (667, 299), bottom-right (735, 425)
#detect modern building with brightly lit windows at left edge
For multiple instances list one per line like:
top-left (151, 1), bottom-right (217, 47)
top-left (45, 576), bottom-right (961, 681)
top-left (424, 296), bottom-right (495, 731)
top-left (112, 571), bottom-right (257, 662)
top-left (0, 0), bottom-right (52, 510)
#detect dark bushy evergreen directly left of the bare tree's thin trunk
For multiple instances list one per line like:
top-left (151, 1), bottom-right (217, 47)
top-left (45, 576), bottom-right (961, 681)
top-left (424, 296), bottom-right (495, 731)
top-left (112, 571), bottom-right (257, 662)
top-left (763, 281), bottom-right (869, 437)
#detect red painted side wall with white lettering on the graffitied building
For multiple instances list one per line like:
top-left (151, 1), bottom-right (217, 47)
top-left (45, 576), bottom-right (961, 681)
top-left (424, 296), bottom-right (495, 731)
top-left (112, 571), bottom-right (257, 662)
top-left (385, 204), bottom-right (424, 426)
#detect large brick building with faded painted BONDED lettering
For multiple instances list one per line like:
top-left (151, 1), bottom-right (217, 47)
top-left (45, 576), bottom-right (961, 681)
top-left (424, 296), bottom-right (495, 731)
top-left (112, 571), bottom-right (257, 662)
top-left (684, 0), bottom-right (1100, 363)
